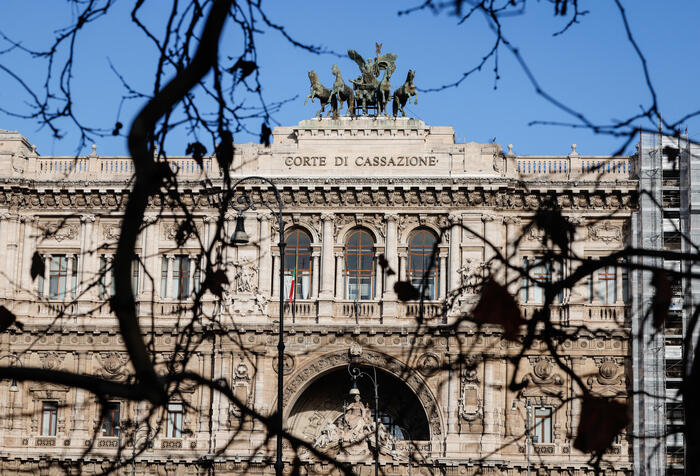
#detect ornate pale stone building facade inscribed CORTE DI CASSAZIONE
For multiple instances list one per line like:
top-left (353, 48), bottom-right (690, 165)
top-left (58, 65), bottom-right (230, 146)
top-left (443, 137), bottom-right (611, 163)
top-left (0, 118), bottom-right (638, 476)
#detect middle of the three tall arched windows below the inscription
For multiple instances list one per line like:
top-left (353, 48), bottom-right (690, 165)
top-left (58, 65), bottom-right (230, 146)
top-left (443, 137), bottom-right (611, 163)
top-left (345, 230), bottom-right (375, 301)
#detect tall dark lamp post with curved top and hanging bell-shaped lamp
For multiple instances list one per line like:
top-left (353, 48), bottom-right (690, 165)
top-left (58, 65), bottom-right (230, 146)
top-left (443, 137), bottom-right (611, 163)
top-left (231, 175), bottom-right (286, 476)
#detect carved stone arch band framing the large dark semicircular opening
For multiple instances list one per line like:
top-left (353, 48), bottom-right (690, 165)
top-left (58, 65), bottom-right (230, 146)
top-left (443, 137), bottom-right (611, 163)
top-left (282, 349), bottom-right (444, 439)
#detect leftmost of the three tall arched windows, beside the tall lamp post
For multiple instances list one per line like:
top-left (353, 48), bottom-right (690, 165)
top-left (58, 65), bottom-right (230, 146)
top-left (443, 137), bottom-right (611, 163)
top-left (284, 229), bottom-right (313, 300)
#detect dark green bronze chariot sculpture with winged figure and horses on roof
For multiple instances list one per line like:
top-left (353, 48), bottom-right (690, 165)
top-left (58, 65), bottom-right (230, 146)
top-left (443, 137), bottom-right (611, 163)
top-left (304, 43), bottom-right (418, 119)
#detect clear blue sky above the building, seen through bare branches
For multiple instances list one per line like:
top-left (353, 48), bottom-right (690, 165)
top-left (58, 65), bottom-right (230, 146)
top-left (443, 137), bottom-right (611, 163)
top-left (0, 0), bottom-right (700, 155)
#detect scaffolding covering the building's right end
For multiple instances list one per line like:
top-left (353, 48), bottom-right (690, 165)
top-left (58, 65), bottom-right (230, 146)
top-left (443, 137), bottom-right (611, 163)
top-left (631, 128), bottom-right (700, 475)
